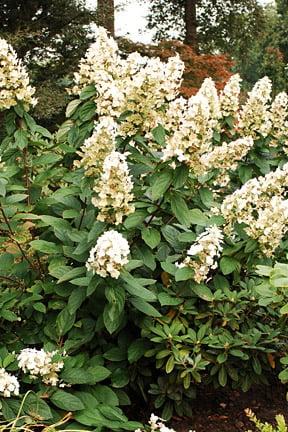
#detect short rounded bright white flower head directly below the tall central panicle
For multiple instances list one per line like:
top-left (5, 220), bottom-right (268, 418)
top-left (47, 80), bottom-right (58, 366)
top-left (86, 230), bottom-right (130, 279)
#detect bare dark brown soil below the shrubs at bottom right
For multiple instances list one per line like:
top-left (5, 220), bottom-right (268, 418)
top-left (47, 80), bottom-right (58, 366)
top-left (167, 377), bottom-right (288, 432)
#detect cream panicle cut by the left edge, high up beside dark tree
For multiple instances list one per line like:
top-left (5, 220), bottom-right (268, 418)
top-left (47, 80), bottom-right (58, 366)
top-left (0, 39), bottom-right (37, 109)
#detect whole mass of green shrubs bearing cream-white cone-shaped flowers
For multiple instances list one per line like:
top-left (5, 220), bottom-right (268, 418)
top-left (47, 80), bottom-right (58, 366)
top-left (0, 28), bottom-right (288, 431)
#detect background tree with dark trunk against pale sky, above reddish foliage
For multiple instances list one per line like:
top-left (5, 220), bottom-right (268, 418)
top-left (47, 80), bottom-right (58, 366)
top-left (144, 0), bottom-right (264, 55)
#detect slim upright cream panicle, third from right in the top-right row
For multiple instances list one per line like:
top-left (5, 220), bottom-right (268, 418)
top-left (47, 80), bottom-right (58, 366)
top-left (219, 74), bottom-right (242, 118)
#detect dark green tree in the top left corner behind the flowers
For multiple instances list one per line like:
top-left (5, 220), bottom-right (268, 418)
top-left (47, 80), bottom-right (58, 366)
top-left (0, 0), bottom-right (97, 126)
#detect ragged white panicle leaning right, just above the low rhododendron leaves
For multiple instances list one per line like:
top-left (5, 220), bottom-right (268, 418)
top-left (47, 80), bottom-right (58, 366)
top-left (175, 225), bottom-right (223, 283)
